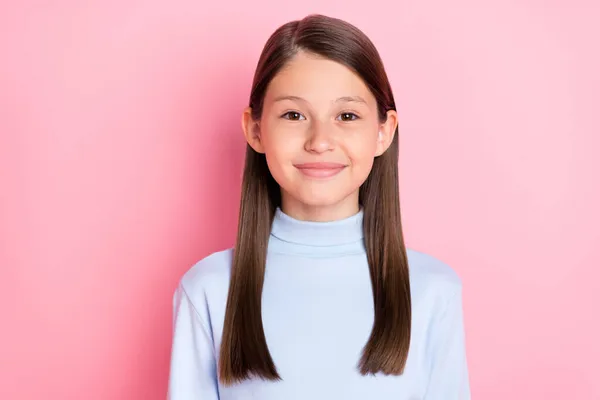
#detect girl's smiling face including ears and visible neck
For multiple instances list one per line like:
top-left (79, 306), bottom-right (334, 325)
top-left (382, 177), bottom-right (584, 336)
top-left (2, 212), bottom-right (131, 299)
top-left (242, 52), bottom-right (397, 220)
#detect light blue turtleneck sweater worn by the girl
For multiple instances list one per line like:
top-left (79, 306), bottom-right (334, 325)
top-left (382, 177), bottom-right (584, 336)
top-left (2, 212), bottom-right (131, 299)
top-left (168, 209), bottom-right (470, 400)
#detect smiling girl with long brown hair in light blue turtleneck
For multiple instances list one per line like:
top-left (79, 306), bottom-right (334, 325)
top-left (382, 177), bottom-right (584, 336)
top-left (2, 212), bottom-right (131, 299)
top-left (169, 15), bottom-right (470, 400)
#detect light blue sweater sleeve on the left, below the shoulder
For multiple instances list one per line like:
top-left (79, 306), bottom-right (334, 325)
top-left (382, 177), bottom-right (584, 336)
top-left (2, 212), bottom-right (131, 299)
top-left (167, 284), bottom-right (219, 400)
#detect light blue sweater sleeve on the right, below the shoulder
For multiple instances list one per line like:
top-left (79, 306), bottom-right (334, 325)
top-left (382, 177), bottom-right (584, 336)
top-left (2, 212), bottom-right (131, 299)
top-left (425, 288), bottom-right (471, 400)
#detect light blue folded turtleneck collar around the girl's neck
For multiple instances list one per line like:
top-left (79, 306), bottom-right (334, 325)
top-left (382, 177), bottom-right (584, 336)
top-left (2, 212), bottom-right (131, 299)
top-left (269, 207), bottom-right (364, 255)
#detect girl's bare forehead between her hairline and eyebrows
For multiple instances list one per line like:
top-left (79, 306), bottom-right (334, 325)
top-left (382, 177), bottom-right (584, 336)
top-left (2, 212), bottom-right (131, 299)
top-left (265, 52), bottom-right (375, 104)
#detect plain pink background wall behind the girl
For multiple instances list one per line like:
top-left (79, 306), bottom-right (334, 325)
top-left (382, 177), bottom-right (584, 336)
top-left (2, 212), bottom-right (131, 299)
top-left (0, 0), bottom-right (600, 400)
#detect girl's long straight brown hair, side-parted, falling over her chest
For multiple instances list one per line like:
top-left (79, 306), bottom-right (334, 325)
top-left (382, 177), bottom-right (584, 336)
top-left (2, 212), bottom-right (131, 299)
top-left (219, 14), bottom-right (411, 385)
